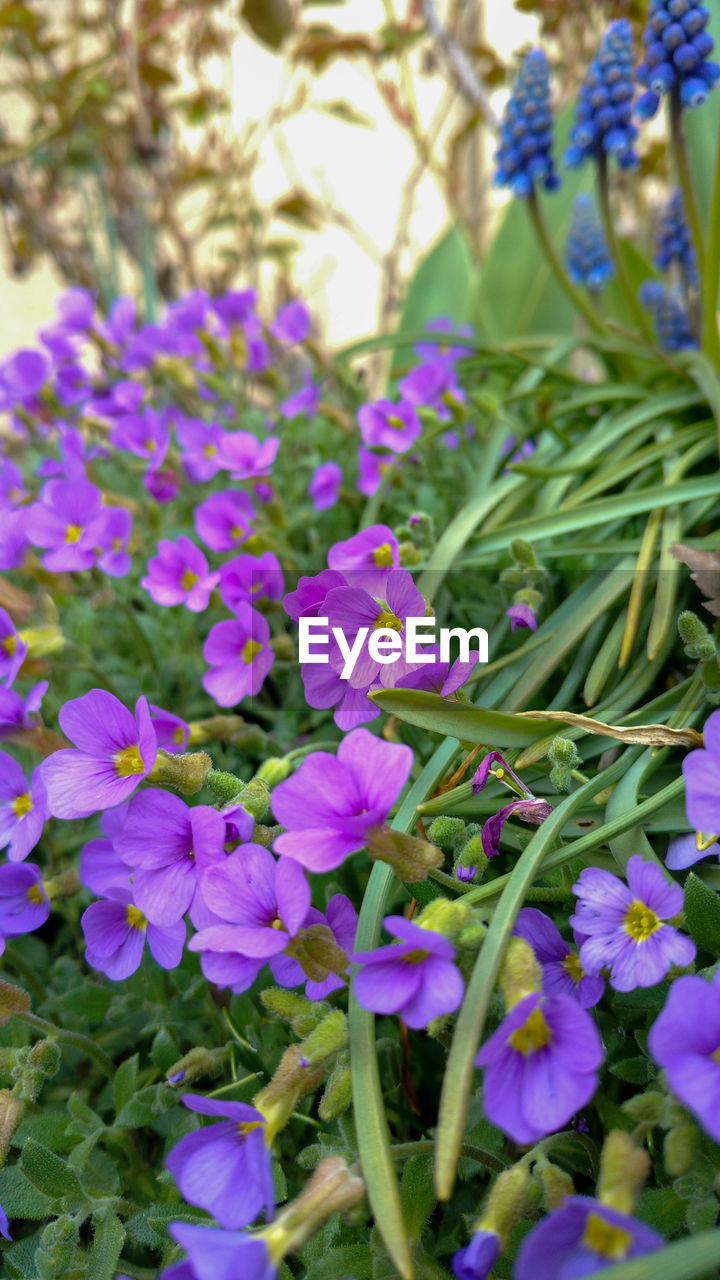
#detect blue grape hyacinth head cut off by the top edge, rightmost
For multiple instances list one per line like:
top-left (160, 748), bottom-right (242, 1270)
top-left (635, 0), bottom-right (720, 120)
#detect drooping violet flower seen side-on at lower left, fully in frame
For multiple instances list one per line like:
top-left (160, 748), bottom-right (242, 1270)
top-left (165, 1093), bottom-right (274, 1229)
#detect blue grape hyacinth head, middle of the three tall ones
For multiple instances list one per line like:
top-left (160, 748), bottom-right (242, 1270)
top-left (564, 18), bottom-right (638, 169)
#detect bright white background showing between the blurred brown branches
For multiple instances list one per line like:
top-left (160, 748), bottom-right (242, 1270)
top-left (0, 0), bottom-right (537, 355)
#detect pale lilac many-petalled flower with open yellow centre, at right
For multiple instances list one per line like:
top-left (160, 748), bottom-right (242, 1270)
top-left (570, 854), bottom-right (696, 991)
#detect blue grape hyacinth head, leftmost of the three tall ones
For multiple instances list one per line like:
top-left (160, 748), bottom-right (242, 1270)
top-left (495, 49), bottom-right (560, 198)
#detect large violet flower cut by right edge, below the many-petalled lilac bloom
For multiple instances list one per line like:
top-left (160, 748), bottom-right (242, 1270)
top-left (647, 974), bottom-right (720, 1142)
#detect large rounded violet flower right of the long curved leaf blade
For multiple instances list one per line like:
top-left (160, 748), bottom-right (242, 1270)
top-left (475, 992), bottom-right (602, 1146)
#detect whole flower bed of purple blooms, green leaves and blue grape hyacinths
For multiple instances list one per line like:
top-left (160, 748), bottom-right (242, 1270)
top-left (0, 0), bottom-right (720, 1280)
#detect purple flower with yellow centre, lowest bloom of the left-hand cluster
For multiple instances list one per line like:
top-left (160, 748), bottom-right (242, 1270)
top-left (79, 887), bottom-right (184, 982)
